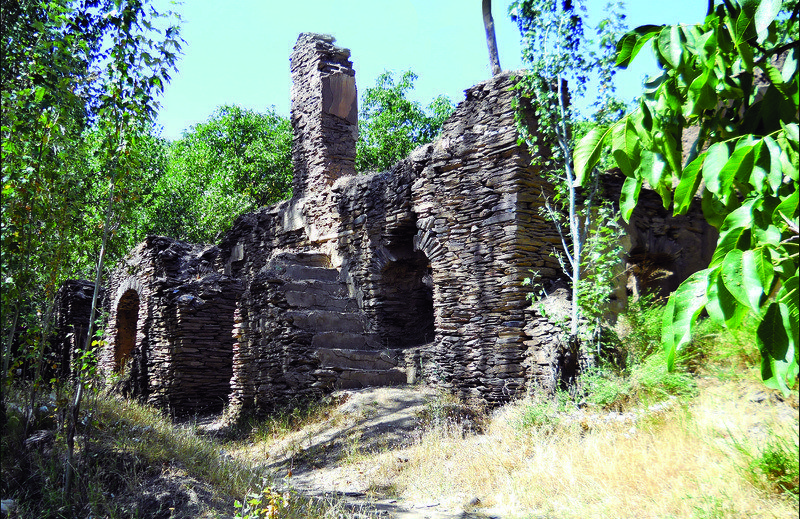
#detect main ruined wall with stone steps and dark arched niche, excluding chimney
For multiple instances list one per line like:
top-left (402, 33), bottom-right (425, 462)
top-left (217, 52), bottom-right (559, 409)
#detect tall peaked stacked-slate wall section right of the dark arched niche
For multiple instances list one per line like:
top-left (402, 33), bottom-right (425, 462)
top-left (406, 74), bottom-right (559, 403)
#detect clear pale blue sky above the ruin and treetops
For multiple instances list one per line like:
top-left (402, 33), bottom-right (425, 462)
top-left (156, 0), bottom-right (707, 139)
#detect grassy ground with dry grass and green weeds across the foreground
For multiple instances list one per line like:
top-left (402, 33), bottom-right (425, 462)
top-left (0, 305), bottom-right (800, 519)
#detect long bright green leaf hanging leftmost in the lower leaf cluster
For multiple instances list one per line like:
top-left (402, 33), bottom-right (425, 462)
top-left (661, 269), bottom-right (711, 370)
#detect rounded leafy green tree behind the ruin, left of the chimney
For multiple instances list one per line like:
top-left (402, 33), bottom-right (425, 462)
top-left (136, 105), bottom-right (292, 246)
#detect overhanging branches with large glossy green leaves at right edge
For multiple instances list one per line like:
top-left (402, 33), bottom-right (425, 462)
top-left (574, 0), bottom-right (800, 392)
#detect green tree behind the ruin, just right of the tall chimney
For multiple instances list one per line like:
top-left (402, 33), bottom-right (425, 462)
top-left (356, 70), bottom-right (455, 171)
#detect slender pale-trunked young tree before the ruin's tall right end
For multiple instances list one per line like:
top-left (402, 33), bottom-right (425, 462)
top-left (509, 0), bottom-right (624, 348)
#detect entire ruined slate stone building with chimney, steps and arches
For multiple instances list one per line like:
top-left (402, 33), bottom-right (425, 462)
top-left (56, 34), bottom-right (715, 414)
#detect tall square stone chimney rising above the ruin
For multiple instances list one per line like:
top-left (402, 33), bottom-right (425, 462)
top-left (291, 33), bottom-right (358, 198)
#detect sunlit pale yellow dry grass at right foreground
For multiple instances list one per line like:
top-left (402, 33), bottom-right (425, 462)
top-left (364, 372), bottom-right (798, 518)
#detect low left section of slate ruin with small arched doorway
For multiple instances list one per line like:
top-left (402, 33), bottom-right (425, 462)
top-left (100, 236), bottom-right (241, 414)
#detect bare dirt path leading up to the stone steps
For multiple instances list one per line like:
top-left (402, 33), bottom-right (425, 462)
top-left (227, 386), bottom-right (497, 519)
